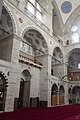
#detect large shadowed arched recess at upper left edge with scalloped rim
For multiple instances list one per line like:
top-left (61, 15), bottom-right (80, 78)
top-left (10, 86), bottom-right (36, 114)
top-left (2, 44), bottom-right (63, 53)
top-left (0, 3), bottom-right (16, 61)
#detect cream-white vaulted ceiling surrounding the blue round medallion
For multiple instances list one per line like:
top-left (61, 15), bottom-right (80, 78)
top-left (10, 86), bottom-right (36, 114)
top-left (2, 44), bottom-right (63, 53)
top-left (37, 0), bottom-right (80, 24)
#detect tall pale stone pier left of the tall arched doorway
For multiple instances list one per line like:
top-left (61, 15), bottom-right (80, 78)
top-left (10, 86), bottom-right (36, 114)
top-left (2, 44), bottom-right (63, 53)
top-left (5, 36), bottom-right (20, 111)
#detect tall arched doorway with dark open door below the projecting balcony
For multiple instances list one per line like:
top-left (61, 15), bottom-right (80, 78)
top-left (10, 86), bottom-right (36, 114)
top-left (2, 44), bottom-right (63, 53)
top-left (19, 70), bottom-right (31, 107)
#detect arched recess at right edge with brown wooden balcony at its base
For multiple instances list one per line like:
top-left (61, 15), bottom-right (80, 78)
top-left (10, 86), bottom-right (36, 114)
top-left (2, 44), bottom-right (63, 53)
top-left (67, 48), bottom-right (80, 81)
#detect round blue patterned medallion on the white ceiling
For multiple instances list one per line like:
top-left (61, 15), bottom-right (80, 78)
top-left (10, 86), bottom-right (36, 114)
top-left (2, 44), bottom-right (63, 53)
top-left (61, 1), bottom-right (72, 14)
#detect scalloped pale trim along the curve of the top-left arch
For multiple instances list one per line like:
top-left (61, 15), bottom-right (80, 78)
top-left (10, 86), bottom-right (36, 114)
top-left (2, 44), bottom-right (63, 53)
top-left (3, 2), bottom-right (17, 34)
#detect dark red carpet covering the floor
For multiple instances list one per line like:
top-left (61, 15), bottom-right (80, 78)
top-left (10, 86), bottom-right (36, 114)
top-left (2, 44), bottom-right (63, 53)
top-left (0, 104), bottom-right (80, 120)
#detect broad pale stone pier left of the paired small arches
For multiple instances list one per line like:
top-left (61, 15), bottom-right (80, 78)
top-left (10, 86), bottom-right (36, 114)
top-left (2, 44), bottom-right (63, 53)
top-left (40, 55), bottom-right (51, 106)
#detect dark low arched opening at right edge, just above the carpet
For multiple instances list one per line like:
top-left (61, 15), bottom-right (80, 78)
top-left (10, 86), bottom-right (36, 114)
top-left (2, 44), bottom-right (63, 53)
top-left (72, 86), bottom-right (80, 103)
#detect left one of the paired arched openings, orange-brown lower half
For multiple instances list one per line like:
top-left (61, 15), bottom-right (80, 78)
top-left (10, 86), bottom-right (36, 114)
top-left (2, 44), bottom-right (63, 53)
top-left (51, 84), bottom-right (58, 105)
